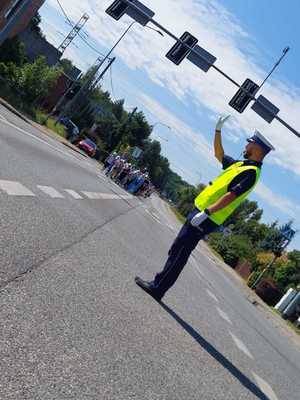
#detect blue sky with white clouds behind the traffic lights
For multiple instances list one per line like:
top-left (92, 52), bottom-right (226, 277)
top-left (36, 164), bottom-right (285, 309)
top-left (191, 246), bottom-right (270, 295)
top-left (40, 0), bottom-right (300, 249)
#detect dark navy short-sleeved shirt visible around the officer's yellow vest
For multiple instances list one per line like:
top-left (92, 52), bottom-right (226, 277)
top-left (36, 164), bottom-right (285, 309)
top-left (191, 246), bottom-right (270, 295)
top-left (222, 155), bottom-right (262, 196)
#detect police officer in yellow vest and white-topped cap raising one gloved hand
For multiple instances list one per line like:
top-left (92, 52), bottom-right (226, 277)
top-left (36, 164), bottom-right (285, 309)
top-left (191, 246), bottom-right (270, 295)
top-left (135, 116), bottom-right (275, 301)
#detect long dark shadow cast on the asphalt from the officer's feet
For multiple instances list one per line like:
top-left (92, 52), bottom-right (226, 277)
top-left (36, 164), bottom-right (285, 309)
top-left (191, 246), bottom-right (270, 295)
top-left (160, 303), bottom-right (270, 400)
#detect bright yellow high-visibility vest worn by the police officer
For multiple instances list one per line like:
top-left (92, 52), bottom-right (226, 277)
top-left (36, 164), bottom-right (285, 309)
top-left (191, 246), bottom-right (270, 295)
top-left (195, 161), bottom-right (261, 225)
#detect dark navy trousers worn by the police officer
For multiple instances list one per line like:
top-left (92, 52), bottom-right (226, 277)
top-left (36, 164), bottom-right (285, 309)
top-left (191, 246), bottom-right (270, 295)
top-left (151, 209), bottom-right (218, 295)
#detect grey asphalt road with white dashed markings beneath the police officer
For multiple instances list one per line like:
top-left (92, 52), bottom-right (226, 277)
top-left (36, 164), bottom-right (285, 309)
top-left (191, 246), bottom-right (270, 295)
top-left (0, 107), bottom-right (300, 400)
